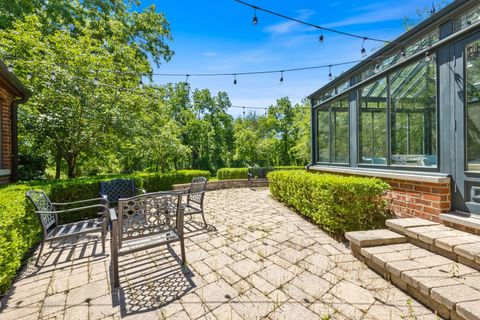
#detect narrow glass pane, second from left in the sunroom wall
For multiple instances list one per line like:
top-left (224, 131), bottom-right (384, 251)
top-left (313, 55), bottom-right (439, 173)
top-left (331, 97), bottom-right (350, 163)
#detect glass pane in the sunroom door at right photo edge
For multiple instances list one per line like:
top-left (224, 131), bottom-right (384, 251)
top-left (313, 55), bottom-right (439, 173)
top-left (466, 41), bottom-right (480, 171)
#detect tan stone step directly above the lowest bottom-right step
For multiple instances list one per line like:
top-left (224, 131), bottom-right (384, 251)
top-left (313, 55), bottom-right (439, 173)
top-left (386, 218), bottom-right (480, 270)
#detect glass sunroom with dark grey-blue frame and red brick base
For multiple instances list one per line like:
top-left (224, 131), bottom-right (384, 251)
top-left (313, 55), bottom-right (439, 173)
top-left (309, 0), bottom-right (480, 225)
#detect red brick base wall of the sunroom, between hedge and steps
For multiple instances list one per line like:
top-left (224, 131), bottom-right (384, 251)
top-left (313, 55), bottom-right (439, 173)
top-left (382, 179), bottom-right (452, 222)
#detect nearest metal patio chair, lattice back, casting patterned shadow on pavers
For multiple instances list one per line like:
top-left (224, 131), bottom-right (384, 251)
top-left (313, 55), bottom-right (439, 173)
top-left (110, 191), bottom-right (186, 288)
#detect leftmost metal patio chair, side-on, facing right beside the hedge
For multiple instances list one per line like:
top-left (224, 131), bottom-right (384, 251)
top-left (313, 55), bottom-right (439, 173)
top-left (26, 190), bottom-right (109, 266)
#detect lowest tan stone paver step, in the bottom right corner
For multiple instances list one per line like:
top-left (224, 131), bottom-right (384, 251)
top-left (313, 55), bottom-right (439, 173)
top-left (352, 243), bottom-right (480, 320)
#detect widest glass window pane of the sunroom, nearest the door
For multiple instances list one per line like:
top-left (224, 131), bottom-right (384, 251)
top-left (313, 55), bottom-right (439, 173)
top-left (390, 59), bottom-right (437, 167)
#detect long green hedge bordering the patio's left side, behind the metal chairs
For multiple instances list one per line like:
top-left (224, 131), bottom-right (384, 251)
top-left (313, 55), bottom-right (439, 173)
top-left (0, 170), bottom-right (210, 296)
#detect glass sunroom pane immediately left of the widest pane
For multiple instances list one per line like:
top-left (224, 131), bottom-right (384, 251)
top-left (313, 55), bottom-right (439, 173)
top-left (359, 78), bottom-right (387, 165)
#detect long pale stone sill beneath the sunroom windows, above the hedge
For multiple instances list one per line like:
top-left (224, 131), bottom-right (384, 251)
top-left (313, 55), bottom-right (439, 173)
top-left (309, 165), bottom-right (450, 183)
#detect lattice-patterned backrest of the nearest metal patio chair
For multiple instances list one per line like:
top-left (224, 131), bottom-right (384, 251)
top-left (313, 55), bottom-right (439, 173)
top-left (118, 191), bottom-right (183, 242)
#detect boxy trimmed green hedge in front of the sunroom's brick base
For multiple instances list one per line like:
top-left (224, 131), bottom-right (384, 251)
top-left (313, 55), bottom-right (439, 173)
top-left (268, 171), bottom-right (389, 236)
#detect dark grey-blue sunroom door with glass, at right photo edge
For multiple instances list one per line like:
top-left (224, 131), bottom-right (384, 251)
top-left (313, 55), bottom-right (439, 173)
top-left (452, 32), bottom-right (480, 217)
